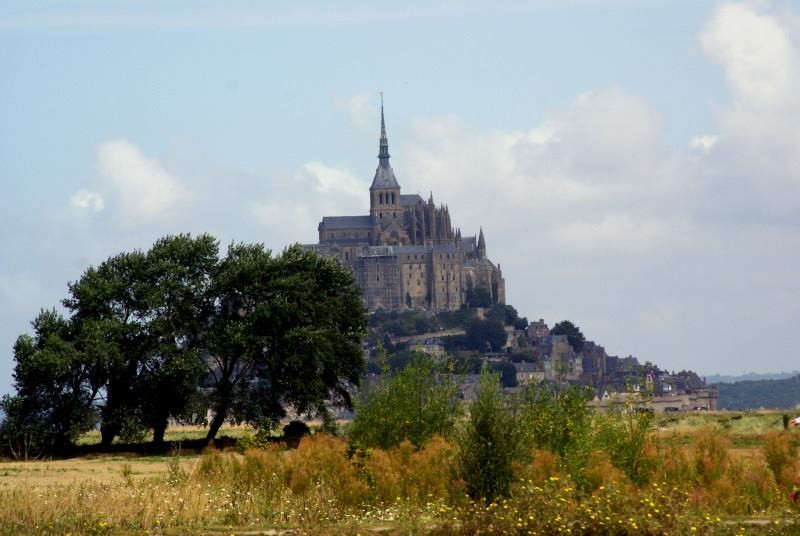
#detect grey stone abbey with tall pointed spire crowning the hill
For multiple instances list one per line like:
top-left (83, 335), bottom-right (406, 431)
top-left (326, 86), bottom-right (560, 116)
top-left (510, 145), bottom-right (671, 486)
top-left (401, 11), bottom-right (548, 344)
top-left (308, 103), bottom-right (505, 311)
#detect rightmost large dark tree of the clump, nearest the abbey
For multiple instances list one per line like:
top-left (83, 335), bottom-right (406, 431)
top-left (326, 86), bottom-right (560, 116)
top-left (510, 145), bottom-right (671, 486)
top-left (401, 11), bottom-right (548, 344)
top-left (205, 244), bottom-right (366, 438)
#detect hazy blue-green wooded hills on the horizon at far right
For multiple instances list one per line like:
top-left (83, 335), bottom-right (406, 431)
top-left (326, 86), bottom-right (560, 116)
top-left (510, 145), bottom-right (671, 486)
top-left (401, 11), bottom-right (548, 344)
top-left (718, 375), bottom-right (800, 409)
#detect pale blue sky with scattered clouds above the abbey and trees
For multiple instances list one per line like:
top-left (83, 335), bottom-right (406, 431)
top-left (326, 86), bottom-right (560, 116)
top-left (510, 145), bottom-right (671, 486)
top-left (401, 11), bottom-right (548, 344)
top-left (0, 0), bottom-right (800, 393)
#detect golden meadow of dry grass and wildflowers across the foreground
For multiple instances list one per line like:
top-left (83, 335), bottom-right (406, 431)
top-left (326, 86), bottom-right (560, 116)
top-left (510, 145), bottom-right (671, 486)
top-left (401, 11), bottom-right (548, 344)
top-left (0, 412), bottom-right (800, 535)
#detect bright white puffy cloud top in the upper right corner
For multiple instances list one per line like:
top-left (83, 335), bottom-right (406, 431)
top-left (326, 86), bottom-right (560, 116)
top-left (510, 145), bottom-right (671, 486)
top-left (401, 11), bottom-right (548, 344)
top-left (700, 4), bottom-right (795, 106)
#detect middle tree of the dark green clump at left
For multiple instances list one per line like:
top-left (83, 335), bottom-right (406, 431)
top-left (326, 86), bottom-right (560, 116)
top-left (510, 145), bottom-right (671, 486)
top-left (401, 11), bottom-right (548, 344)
top-left (64, 235), bottom-right (218, 446)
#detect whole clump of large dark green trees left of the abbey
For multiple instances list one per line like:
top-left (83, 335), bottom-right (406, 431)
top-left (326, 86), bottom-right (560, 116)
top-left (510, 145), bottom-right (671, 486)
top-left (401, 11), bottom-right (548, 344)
top-left (0, 234), bottom-right (366, 450)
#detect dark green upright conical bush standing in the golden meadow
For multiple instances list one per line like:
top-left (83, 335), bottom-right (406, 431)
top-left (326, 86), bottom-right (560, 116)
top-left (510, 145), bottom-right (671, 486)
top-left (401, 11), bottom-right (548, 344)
top-left (457, 371), bottom-right (522, 502)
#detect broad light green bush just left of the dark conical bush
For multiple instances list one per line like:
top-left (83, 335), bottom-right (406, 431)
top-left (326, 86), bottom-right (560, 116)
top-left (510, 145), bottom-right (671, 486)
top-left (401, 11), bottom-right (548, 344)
top-left (348, 352), bottom-right (461, 448)
